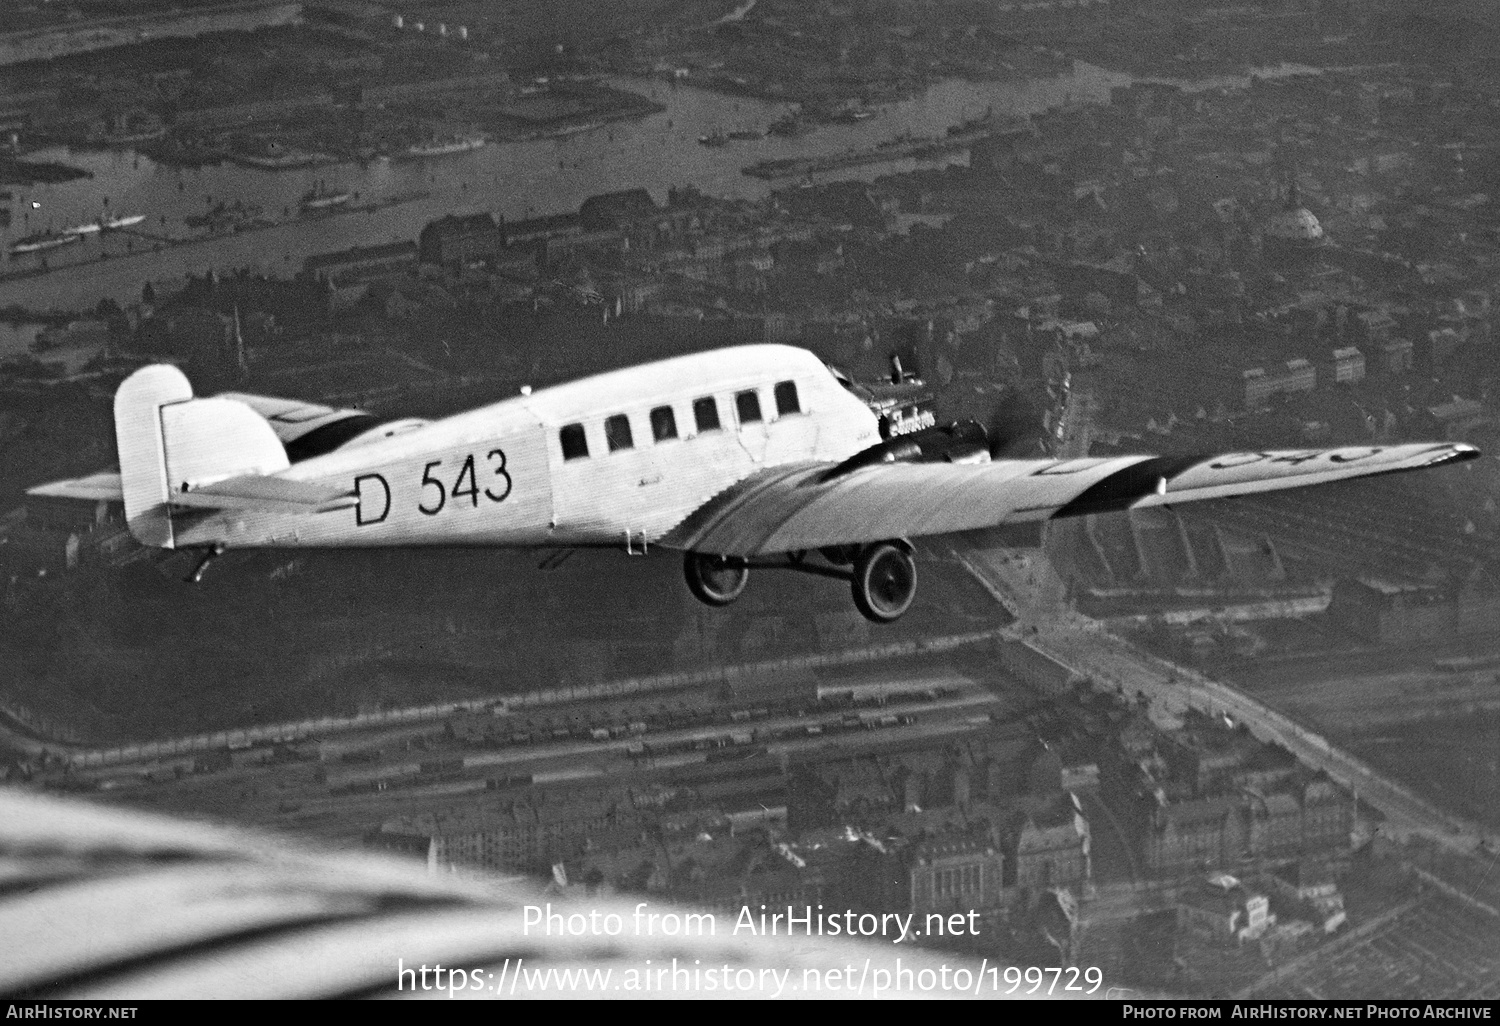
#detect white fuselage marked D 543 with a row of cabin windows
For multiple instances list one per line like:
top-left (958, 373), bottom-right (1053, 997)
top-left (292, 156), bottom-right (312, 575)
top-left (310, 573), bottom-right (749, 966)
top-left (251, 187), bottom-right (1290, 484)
top-left (173, 345), bottom-right (881, 551)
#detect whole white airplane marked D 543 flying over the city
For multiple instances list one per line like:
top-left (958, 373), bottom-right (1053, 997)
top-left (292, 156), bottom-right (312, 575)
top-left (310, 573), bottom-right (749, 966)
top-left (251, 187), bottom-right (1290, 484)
top-left (29, 345), bottom-right (1479, 624)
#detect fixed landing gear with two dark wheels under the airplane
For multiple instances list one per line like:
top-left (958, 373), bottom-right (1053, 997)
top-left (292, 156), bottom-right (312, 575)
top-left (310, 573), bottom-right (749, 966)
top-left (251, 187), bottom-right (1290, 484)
top-left (683, 540), bottom-right (917, 624)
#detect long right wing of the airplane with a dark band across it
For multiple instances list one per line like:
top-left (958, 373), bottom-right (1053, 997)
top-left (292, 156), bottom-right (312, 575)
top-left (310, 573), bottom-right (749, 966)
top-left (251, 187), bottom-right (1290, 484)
top-left (657, 443), bottom-right (1479, 557)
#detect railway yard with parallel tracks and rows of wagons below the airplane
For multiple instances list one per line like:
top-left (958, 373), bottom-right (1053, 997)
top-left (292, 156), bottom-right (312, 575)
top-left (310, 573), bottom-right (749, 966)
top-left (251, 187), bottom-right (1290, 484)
top-left (32, 665), bottom-right (1035, 846)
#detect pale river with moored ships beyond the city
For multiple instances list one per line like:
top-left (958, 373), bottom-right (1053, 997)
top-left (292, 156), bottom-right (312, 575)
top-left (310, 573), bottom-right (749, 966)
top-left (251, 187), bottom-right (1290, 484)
top-left (0, 62), bottom-right (1313, 316)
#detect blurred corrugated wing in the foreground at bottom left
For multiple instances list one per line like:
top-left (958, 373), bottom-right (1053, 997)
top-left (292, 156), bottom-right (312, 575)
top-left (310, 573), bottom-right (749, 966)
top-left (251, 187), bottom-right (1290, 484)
top-left (0, 786), bottom-right (972, 1007)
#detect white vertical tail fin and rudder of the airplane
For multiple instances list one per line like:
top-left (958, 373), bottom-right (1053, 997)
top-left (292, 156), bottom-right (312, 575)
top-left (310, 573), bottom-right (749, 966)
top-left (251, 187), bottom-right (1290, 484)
top-left (114, 365), bottom-right (290, 549)
